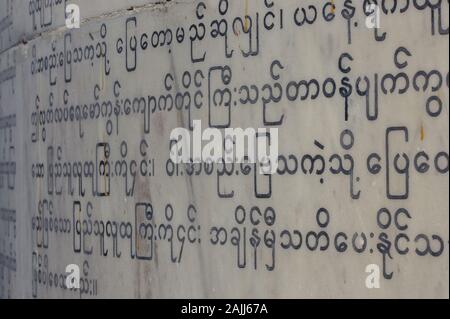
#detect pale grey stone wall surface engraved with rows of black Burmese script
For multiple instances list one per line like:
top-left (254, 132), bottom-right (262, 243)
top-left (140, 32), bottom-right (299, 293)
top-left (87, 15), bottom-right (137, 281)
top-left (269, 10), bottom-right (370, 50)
top-left (0, 0), bottom-right (449, 298)
